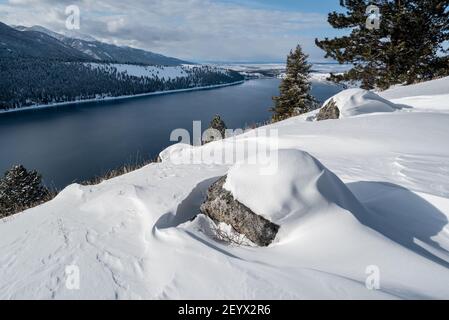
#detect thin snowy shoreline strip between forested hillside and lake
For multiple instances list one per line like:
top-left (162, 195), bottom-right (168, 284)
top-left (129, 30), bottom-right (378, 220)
top-left (0, 80), bottom-right (246, 115)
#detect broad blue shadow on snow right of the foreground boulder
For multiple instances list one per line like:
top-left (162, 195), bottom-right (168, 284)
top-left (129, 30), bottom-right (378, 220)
top-left (347, 181), bottom-right (449, 268)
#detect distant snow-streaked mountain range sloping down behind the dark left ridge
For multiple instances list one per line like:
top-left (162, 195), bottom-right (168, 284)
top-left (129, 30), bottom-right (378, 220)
top-left (11, 26), bottom-right (188, 66)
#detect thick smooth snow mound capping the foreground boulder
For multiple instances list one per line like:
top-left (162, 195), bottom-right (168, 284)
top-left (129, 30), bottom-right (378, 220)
top-left (224, 149), bottom-right (362, 238)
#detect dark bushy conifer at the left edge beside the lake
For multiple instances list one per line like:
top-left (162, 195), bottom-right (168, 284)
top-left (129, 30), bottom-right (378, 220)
top-left (0, 165), bottom-right (50, 216)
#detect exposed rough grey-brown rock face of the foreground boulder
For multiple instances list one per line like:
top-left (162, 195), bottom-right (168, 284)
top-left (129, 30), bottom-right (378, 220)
top-left (201, 176), bottom-right (279, 247)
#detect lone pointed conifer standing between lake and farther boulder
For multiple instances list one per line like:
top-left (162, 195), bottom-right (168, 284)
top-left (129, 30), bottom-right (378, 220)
top-left (271, 45), bottom-right (315, 122)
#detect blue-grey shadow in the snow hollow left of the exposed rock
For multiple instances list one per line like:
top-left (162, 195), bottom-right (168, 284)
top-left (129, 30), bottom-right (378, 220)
top-left (155, 177), bottom-right (220, 229)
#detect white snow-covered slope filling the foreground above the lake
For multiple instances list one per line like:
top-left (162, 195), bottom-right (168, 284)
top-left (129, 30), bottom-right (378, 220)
top-left (0, 79), bottom-right (449, 299)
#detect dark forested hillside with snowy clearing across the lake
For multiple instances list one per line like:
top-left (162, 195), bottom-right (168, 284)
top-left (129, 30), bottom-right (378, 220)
top-left (0, 58), bottom-right (243, 110)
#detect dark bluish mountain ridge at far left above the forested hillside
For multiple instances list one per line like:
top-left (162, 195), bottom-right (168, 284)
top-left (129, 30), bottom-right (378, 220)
top-left (0, 22), bottom-right (92, 61)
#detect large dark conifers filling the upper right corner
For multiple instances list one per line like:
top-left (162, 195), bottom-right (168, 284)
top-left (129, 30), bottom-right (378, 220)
top-left (316, 0), bottom-right (449, 89)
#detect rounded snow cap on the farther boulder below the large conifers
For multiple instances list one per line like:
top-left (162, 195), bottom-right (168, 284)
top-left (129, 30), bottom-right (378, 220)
top-left (321, 89), bottom-right (398, 120)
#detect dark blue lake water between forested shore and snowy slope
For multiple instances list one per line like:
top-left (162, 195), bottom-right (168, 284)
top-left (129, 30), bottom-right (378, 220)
top-left (0, 79), bottom-right (341, 188)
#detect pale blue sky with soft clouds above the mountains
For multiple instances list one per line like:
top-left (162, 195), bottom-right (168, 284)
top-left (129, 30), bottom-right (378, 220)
top-left (0, 0), bottom-right (341, 62)
